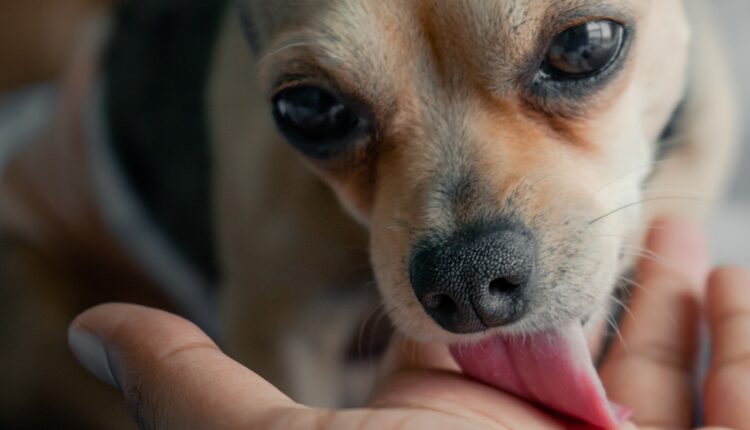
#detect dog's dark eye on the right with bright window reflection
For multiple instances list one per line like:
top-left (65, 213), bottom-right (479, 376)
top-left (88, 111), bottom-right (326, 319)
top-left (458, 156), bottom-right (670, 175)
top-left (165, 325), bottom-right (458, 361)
top-left (545, 20), bottom-right (625, 80)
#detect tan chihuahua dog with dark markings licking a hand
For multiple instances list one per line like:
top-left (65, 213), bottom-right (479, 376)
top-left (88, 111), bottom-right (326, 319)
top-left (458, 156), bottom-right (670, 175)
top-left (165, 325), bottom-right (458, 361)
top-left (0, 0), bottom-right (734, 428)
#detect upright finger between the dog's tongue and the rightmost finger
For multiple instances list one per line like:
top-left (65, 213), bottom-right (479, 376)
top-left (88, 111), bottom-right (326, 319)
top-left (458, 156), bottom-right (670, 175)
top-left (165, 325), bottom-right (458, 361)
top-left (601, 220), bottom-right (709, 428)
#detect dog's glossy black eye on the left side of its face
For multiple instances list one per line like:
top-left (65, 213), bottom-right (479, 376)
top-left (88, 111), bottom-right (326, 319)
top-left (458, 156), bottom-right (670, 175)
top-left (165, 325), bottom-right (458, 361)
top-left (273, 87), bottom-right (364, 158)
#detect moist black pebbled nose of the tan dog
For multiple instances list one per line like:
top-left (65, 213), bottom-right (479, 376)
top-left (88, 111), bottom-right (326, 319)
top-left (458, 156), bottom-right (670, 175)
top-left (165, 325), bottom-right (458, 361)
top-left (411, 223), bottom-right (536, 333)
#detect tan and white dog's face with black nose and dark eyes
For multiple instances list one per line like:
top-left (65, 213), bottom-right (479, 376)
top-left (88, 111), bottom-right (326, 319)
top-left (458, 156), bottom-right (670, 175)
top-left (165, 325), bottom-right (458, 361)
top-left (241, 0), bottom-right (688, 342)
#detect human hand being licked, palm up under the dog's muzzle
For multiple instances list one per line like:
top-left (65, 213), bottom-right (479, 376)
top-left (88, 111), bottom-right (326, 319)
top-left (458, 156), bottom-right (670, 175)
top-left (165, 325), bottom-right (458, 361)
top-left (69, 222), bottom-right (750, 430)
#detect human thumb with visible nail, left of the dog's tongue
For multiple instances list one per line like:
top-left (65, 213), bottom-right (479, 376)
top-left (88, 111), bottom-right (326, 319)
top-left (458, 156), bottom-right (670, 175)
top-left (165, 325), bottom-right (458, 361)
top-left (69, 305), bottom-right (306, 430)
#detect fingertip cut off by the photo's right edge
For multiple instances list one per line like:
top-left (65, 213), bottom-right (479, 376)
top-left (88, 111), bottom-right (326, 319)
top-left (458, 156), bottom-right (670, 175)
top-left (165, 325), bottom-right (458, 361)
top-left (705, 268), bottom-right (750, 428)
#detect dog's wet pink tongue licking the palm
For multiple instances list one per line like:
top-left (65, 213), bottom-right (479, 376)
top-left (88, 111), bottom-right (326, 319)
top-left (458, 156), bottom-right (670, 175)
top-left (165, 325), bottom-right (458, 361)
top-left (451, 323), bottom-right (630, 430)
